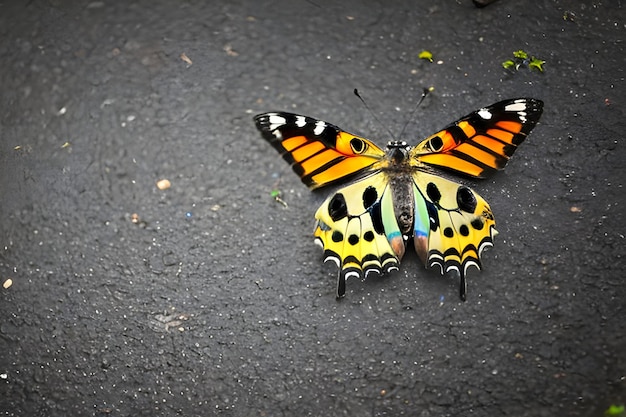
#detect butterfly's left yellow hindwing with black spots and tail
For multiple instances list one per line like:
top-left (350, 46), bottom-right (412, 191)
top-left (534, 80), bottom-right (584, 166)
top-left (314, 173), bottom-right (404, 297)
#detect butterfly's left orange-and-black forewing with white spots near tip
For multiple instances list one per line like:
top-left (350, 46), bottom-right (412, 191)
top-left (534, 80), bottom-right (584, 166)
top-left (254, 112), bottom-right (385, 189)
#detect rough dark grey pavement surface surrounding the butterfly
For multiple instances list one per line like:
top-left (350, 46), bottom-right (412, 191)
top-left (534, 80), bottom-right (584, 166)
top-left (0, 0), bottom-right (626, 417)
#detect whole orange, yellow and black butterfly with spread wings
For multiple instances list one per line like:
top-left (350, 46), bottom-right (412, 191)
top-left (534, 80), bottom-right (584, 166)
top-left (254, 98), bottom-right (543, 301)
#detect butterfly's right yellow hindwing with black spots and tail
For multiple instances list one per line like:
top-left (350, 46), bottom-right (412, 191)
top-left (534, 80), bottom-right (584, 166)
top-left (413, 172), bottom-right (497, 299)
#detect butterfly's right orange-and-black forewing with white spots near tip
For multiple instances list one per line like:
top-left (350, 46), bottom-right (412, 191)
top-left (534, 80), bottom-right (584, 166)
top-left (411, 98), bottom-right (543, 178)
